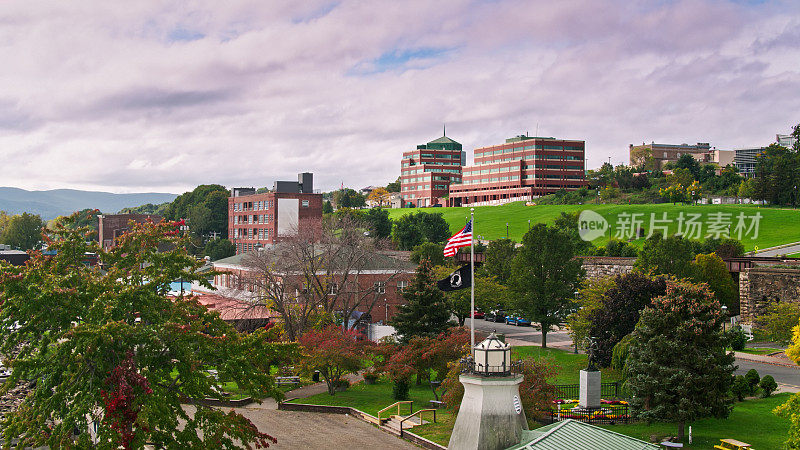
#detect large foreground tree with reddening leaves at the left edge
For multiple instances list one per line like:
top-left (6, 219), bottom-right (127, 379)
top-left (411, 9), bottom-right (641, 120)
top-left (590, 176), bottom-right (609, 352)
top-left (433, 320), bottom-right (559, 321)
top-left (0, 214), bottom-right (293, 449)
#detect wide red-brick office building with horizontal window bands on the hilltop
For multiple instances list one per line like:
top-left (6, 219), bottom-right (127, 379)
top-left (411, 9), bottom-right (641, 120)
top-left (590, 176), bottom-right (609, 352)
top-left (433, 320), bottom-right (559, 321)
top-left (448, 136), bottom-right (587, 206)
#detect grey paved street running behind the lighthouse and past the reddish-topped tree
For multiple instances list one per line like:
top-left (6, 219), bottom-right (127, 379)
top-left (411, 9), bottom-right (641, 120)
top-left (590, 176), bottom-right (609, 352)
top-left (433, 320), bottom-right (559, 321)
top-left (467, 319), bottom-right (800, 391)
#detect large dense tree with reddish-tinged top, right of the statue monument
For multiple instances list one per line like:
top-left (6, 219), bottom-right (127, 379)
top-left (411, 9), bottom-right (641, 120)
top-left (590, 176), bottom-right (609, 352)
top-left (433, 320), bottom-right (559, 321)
top-left (626, 281), bottom-right (734, 440)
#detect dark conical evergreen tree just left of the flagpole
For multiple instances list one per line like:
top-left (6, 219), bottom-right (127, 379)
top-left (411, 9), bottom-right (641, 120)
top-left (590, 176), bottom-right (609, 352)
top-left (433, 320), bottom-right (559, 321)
top-left (391, 260), bottom-right (452, 343)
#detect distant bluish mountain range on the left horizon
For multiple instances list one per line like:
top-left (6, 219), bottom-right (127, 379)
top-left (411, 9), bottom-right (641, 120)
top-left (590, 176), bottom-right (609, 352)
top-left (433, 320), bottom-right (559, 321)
top-left (0, 187), bottom-right (177, 220)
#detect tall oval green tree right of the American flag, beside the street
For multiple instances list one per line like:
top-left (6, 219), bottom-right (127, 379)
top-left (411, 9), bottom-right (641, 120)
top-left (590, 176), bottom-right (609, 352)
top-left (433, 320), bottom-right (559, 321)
top-left (509, 223), bottom-right (585, 347)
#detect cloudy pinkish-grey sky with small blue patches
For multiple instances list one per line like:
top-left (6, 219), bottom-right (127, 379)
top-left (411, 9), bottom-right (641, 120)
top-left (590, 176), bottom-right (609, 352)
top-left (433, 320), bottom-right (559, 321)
top-left (0, 0), bottom-right (800, 193)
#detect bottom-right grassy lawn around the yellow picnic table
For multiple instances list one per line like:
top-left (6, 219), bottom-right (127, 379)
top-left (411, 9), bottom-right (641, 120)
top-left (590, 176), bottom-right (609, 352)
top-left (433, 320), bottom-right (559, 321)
top-left (604, 394), bottom-right (789, 449)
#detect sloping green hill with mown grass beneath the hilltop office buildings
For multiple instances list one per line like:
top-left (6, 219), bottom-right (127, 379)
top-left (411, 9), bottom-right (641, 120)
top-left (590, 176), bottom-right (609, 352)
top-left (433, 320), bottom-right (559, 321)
top-left (389, 202), bottom-right (800, 250)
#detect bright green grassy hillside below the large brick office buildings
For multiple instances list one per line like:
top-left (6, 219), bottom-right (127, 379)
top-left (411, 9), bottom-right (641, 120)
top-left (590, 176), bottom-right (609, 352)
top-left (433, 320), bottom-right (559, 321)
top-left (389, 202), bottom-right (800, 250)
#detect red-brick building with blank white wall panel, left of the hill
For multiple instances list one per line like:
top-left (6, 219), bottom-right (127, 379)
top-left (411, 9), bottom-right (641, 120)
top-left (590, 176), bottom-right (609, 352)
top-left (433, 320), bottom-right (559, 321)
top-left (228, 172), bottom-right (322, 254)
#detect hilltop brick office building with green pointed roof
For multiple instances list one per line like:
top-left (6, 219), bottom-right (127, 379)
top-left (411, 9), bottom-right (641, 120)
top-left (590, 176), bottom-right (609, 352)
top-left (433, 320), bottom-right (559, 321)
top-left (400, 131), bottom-right (466, 207)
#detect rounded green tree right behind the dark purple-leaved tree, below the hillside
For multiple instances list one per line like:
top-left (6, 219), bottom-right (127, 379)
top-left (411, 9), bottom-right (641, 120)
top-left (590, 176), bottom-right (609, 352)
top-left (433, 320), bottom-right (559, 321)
top-left (634, 233), bottom-right (695, 278)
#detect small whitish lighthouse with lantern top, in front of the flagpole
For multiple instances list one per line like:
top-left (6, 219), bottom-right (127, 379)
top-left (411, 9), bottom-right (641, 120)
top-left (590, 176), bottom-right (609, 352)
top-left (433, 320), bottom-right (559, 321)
top-left (447, 333), bottom-right (528, 450)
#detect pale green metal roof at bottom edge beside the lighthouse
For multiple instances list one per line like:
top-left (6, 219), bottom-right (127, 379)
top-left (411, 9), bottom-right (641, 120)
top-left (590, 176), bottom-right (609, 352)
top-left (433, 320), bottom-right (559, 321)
top-left (506, 419), bottom-right (659, 450)
